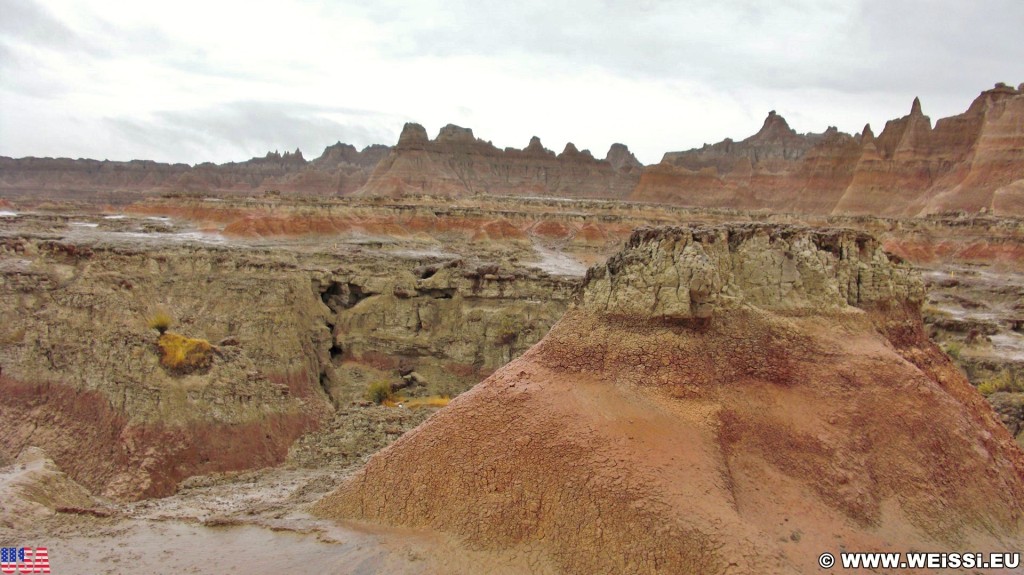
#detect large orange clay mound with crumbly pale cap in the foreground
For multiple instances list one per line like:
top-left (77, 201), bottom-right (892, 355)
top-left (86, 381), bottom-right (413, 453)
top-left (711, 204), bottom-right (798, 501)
top-left (314, 224), bottom-right (1024, 574)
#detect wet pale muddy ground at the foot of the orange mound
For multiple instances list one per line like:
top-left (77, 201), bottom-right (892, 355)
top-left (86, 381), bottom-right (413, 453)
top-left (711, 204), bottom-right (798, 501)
top-left (0, 454), bottom-right (548, 575)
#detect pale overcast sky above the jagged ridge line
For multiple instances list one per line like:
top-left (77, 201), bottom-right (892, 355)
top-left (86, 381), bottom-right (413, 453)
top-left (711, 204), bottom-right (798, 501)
top-left (0, 0), bottom-right (1024, 164)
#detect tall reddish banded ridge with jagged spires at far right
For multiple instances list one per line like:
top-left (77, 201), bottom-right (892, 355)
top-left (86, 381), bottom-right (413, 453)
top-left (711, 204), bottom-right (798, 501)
top-left (631, 84), bottom-right (1024, 216)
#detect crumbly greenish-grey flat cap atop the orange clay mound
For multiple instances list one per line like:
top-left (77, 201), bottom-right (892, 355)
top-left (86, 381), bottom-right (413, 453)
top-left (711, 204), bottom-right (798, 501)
top-left (575, 224), bottom-right (924, 321)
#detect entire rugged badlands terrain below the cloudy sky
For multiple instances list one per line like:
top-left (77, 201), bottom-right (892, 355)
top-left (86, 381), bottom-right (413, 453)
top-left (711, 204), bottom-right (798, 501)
top-left (0, 79), bottom-right (1024, 574)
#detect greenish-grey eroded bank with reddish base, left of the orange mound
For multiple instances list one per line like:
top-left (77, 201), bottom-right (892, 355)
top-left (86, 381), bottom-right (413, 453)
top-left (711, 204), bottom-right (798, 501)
top-left (0, 215), bottom-right (577, 499)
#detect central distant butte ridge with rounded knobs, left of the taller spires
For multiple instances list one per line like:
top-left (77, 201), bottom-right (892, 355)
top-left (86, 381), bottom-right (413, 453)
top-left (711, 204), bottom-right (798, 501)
top-left (359, 124), bottom-right (640, 198)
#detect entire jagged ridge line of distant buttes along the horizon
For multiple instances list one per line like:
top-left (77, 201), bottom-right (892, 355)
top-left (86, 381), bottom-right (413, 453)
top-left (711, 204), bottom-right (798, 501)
top-left (0, 83), bottom-right (1024, 216)
